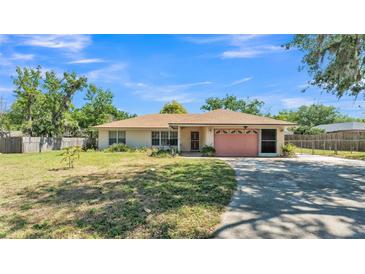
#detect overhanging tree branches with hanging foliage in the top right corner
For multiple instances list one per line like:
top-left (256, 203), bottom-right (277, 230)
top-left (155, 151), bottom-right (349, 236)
top-left (285, 34), bottom-right (365, 98)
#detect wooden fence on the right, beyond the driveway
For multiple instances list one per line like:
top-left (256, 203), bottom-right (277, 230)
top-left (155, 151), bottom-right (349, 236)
top-left (285, 132), bottom-right (365, 151)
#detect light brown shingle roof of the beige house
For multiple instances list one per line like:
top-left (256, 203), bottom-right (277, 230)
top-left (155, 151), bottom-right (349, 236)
top-left (95, 109), bottom-right (295, 128)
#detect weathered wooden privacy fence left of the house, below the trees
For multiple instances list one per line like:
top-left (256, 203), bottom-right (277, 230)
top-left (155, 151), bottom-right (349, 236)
top-left (0, 137), bottom-right (89, 153)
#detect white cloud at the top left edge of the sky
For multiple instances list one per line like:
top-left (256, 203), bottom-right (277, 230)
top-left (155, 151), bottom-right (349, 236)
top-left (23, 35), bottom-right (91, 52)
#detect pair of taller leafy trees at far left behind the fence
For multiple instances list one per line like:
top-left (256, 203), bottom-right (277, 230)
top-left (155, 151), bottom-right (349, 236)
top-left (9, 66), bottom-right (86, 136)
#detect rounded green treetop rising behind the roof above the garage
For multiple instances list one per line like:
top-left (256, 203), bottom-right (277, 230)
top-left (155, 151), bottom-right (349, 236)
top-left (200, 94), bottom-right (264, 115)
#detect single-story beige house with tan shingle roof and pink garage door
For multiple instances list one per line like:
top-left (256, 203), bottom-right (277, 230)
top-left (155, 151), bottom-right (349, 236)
top-left (95, 109), bottom-right (295, 156)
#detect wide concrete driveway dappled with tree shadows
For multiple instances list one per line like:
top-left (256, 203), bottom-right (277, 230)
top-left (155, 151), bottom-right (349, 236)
top-left (215, 155), bottom-right (365, 238)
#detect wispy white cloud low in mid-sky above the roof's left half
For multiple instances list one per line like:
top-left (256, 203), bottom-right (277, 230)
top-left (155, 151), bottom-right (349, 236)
top-left (125, 81), bottom-right (213, 103)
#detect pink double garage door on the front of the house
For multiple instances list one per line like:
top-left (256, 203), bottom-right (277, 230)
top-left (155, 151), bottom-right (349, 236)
top-left (214, 129), bottom-right (258, 156)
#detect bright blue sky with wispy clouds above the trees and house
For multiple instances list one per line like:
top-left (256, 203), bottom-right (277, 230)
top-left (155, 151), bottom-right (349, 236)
top-left (0, 35), bottom-right (365, 117)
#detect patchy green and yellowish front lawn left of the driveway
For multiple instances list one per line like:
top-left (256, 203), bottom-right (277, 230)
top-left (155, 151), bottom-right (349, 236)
top-left (0, 152), bottom-right (236, 238)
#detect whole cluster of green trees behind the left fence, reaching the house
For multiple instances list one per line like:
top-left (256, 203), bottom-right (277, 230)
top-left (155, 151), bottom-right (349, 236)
top-left (6, 66), bottom-right (135, 137)
